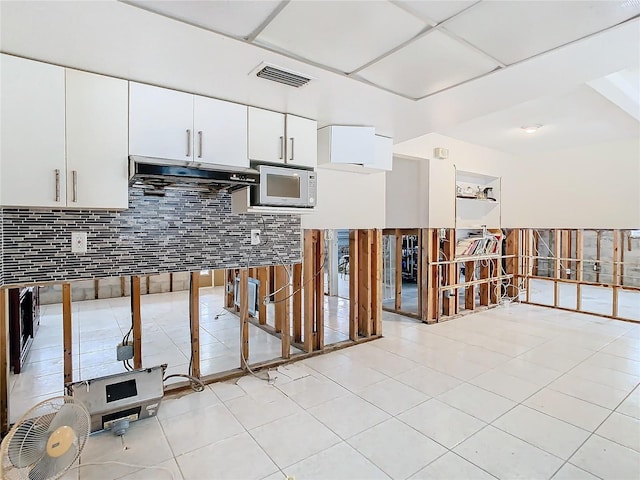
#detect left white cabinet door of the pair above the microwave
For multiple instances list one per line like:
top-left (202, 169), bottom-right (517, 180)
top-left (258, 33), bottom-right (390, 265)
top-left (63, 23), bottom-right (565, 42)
top-left (249, 107), bottom-right (285, 163)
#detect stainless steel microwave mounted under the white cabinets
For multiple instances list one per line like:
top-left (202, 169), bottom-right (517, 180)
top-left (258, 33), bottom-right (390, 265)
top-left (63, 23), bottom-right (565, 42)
top-left (250, 165), bottom-right (317, 208)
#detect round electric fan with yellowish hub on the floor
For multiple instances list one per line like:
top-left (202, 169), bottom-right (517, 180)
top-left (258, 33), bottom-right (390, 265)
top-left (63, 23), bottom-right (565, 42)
top-left (0, 397), bottom-right (89, 480)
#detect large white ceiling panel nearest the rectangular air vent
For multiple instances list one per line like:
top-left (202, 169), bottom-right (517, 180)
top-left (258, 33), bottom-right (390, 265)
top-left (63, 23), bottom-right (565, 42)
top-left (255, 1), bottom-right (427, 72)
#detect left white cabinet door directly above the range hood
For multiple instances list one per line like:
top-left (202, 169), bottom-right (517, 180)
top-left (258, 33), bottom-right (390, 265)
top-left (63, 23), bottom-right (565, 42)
top-left (129, 82), bottom-right (194, 161)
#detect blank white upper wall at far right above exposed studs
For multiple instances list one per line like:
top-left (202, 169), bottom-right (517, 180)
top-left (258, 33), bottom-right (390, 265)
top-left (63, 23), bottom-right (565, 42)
top-left (502, 138), bottom-right (640, 229)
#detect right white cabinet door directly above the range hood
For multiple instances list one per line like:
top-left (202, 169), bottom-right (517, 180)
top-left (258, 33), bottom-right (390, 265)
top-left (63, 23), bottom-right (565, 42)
top-left (193, 96), bottom-right (249, 168)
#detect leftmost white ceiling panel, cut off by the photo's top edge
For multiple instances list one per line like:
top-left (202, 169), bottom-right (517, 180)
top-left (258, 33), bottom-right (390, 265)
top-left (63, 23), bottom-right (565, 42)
top-left (123, 0), bottom-right (280, 38)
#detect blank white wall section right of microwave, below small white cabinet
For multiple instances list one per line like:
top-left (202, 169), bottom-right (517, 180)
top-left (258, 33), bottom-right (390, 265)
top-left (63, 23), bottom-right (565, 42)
top-left (302, 168), bottom-right (385, 229)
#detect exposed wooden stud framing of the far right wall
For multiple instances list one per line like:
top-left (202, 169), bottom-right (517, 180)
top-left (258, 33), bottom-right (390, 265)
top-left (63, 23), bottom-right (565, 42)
top-left (518, 229), bottom-right (640, 322)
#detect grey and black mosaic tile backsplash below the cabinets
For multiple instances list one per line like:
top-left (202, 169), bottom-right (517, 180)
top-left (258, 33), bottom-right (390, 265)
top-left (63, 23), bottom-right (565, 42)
top-left (0, 188), bottom-right (301, 285)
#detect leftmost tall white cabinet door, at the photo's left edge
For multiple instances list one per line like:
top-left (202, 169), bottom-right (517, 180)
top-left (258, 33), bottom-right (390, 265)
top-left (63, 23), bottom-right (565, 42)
top-left (0, 55), bottom-right (65, 207)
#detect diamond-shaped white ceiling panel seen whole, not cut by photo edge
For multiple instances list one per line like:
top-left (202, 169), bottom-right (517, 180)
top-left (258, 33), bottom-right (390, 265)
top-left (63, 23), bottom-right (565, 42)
top-left (358, 30), bottom-right (498, 98)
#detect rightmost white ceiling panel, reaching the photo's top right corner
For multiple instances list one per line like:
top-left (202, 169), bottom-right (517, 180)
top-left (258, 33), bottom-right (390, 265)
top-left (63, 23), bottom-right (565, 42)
top-left (444, 0), bottom-right (640, 65)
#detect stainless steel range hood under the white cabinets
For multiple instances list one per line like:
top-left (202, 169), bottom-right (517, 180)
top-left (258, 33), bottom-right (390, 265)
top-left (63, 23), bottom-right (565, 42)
top-left (129, 155), bottom-right (260, 195)
